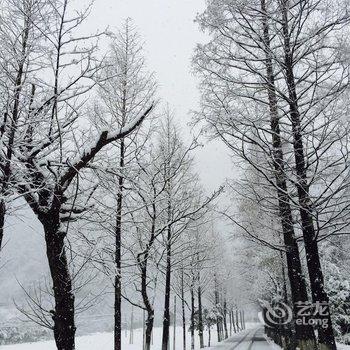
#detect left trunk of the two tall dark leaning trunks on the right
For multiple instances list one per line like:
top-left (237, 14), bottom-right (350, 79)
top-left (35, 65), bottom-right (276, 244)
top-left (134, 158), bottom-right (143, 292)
top-left (261, 0), bottom-right (315, 349)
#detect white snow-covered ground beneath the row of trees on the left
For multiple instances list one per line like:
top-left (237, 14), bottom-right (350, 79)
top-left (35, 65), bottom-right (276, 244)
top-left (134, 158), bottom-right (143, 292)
top-left (0, 323), bottom-right (256, 350)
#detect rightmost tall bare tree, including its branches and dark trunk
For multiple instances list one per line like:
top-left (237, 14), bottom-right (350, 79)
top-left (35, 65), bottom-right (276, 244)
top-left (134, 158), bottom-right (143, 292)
top-left (279, 1), bottom-right (350, 349)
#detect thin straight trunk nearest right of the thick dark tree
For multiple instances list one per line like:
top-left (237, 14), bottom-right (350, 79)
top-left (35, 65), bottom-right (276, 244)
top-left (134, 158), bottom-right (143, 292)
top-left (114, 140), bottom-right (125, 350)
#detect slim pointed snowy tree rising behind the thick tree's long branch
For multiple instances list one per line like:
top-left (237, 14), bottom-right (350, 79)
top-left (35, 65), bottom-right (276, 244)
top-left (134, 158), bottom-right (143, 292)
top-left (91, 19), bottom-right (156, 350)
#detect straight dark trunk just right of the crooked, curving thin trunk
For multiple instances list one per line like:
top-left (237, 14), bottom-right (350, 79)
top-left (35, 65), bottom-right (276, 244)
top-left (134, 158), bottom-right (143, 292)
top-left (162, 220), bottom-right (171, 350)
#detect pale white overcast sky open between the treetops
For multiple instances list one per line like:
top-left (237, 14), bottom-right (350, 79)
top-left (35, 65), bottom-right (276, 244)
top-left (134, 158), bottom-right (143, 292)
top-left (84, 0), bottom-right (232, 190)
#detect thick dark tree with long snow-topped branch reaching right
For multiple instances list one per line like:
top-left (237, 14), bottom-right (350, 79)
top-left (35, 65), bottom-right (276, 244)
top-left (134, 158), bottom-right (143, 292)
top-left (0, 0), bottom-right (152, 349)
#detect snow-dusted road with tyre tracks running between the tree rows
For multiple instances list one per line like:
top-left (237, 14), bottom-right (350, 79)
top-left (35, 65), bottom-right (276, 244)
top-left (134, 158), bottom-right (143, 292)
top-left (213, 328), bottom-right (276, 350)
